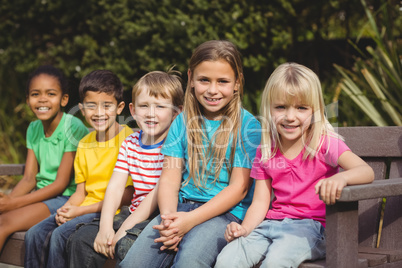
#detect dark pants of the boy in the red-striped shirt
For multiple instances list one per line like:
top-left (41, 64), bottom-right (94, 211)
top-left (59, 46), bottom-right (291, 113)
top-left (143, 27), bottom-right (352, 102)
top-left (67, 206), bottom-right (149, 268)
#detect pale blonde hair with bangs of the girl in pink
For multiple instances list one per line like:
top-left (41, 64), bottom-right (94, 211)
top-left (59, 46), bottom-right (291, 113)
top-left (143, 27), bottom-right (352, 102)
top-left (260, 63), bottom-right (339, 161)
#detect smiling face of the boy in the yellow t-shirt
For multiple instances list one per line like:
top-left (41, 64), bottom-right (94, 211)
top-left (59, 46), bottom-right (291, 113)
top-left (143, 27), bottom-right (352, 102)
top-left (79, 91), bottom-right (124, 141)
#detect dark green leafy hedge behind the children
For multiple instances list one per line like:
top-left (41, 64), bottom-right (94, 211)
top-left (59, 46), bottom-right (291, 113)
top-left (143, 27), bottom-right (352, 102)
top-left (0, 0), bottom-right (402, 163)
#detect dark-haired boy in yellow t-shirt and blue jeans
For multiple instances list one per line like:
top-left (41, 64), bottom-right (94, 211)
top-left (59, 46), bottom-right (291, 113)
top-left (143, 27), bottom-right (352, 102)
top-left (24, 70), bottom-right (133, 268)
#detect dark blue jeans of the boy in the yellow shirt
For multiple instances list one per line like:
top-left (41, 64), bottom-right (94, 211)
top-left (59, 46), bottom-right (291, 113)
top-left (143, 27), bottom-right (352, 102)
top-left (24, 213), bottom-right (100, 268)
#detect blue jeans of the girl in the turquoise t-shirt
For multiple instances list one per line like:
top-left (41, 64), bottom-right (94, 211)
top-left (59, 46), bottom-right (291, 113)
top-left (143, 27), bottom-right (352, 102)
top-left (120, 202), bottom-right (240, 268)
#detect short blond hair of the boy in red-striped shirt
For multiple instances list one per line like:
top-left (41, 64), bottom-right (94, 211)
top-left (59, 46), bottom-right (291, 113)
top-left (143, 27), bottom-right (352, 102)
top-left (131, 67), bottom-right (184, 108)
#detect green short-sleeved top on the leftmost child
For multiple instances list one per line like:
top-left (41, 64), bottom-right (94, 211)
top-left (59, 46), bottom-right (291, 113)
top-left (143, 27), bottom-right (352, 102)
top-left (27, 113), bottom-right (89, 196)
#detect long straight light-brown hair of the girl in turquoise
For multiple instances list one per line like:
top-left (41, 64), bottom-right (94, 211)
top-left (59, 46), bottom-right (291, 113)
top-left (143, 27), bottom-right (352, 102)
top-left (183, 40), bottom-right (244, 188)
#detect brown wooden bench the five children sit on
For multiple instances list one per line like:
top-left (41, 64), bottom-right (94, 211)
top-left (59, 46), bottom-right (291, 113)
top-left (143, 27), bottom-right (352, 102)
top-left (0, 127), bottom-right (402, 268)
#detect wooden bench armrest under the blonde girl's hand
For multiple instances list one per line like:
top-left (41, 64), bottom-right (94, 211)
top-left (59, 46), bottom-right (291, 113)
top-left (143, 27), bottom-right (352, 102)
top-left (338, 178), bottom-right (402, 202)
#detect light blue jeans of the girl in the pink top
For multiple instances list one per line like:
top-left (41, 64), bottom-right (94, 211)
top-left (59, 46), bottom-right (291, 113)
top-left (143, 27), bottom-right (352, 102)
top-left (215, 218), bottom-right (325, 268)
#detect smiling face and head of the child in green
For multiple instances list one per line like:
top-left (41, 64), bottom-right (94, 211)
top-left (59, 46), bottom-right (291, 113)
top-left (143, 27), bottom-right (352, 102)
top-left (27, 74), bottom-right (68, 123)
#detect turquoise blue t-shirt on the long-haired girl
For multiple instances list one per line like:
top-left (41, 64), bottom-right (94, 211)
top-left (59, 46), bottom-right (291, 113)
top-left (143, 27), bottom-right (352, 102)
top-left (161, 110), bottom-right (261, 219)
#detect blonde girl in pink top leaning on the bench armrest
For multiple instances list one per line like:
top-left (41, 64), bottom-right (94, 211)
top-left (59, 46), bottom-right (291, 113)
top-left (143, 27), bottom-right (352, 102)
top-left (215, 63), bottom-right (374, 268)
